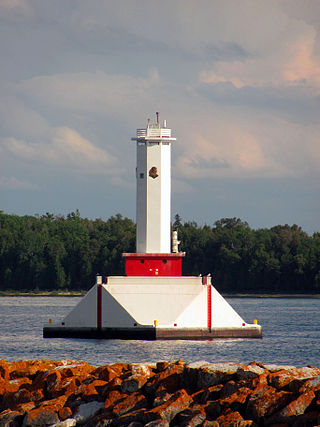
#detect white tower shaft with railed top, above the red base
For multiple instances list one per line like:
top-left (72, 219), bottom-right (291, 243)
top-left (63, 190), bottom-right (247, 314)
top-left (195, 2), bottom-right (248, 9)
top-left (131, 113), bottom-right (176, 253)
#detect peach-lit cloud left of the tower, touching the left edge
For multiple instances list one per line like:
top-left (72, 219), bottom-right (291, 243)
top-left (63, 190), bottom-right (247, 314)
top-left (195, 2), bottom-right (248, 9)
top-left (2, 127), bottom-right (119, 175)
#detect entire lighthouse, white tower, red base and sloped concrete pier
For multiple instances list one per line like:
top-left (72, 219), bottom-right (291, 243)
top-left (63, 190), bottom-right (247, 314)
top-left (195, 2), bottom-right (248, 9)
top-left (43, 113), bottom-right (262, 340)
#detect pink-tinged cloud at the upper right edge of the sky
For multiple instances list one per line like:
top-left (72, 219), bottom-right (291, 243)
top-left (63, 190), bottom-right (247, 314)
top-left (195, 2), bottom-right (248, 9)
top-left (199, 27), bottom-right (320, 94)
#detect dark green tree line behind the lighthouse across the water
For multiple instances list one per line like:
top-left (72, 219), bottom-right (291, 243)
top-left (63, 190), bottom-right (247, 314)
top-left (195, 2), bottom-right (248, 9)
top-left (0, 211), bottom-right (320, 293)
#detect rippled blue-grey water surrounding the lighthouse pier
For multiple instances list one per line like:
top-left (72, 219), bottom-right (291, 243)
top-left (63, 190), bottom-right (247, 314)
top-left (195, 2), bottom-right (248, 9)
top-left (0, 297), bottom-right (320, 367)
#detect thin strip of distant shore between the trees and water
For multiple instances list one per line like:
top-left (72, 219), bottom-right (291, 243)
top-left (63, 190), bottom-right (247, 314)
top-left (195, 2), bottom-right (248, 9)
top-left (0, 290), bottom-right (320, 299)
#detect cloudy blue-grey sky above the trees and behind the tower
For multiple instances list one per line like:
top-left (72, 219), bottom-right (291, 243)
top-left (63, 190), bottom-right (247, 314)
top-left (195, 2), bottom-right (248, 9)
top-left (0, 0), bottom-right (320, 234)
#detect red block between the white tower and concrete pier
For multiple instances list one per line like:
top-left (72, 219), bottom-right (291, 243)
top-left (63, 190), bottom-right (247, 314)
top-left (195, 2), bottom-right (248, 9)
top-left (122, 252), bottom-right (185, 276)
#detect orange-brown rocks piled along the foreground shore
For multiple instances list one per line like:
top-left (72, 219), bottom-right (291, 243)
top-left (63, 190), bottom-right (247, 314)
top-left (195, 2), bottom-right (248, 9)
top-left (0, 359), bottom-right (320, 427)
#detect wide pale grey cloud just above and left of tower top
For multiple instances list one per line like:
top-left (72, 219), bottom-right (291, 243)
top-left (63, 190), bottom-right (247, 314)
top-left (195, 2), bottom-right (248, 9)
top-left (16, 69), bottom-right (159, 115)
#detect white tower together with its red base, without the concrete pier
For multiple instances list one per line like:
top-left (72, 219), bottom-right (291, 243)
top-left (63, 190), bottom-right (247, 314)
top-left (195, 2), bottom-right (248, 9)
top-left (123, 112), bottom-right (185, 276)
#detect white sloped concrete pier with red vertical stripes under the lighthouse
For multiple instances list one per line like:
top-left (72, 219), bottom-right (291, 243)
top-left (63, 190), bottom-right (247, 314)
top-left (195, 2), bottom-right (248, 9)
top-left (44, 276), bottom-right (262, 339)
